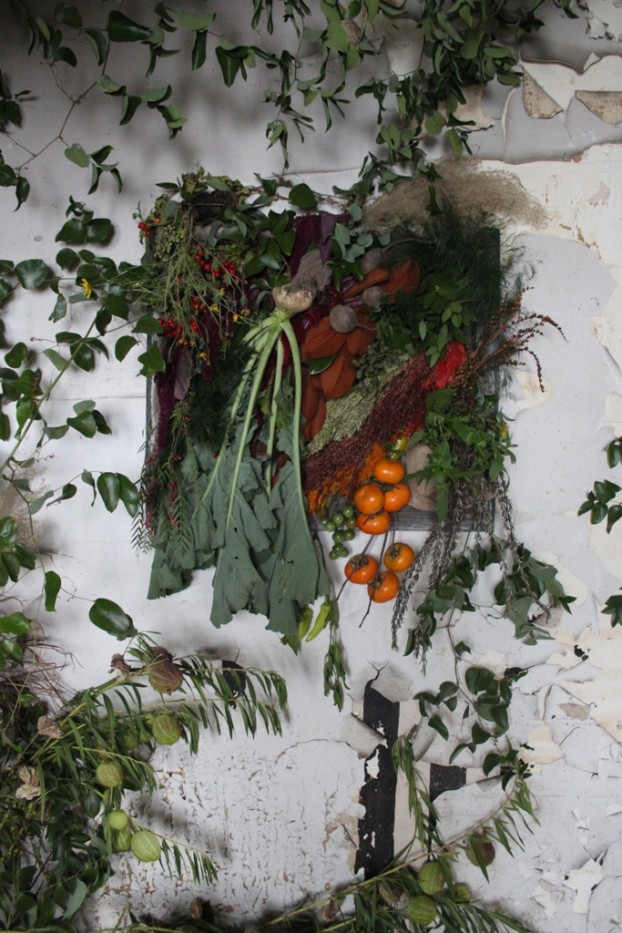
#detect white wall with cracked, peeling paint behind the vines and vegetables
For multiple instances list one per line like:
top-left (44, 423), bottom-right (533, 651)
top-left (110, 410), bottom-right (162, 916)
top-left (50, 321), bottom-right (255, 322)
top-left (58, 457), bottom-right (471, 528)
top-left (0, 0), bottom-right (622, 933)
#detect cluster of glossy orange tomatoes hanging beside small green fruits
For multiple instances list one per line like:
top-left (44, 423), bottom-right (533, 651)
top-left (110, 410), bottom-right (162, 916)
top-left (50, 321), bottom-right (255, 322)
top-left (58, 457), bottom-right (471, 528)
top-left (324, 457), bottom-right (416, 603)
